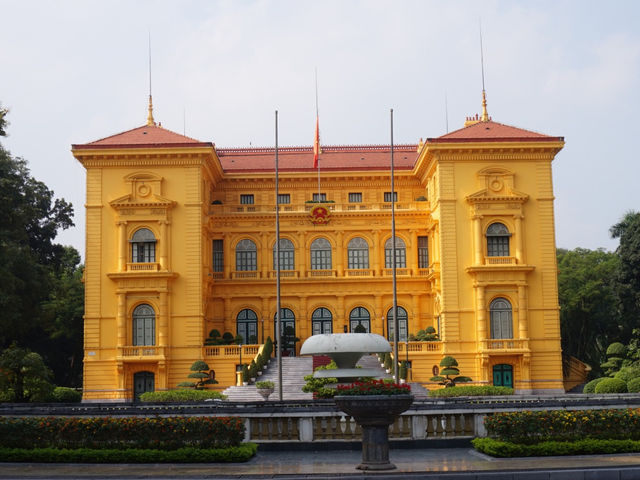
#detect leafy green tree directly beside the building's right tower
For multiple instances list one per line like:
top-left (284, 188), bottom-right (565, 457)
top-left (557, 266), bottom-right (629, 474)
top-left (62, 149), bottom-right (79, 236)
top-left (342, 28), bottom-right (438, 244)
top-left (557, 248), bottom-right (620, 373)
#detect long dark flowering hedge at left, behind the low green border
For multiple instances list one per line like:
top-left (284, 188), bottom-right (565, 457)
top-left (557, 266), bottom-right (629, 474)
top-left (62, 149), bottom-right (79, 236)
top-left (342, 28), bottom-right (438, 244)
top-left (0, 417), bottom-right (244, 450)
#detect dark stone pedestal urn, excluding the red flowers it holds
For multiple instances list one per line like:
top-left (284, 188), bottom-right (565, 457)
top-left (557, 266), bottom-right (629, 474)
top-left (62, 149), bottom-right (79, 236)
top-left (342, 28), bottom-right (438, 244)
top-left (333, 395), bottom-right (413, 470)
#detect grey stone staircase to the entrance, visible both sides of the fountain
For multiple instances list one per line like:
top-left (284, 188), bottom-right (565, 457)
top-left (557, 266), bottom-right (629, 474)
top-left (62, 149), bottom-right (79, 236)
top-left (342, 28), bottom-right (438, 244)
top-left (222, 354), bottom-right (428, 402)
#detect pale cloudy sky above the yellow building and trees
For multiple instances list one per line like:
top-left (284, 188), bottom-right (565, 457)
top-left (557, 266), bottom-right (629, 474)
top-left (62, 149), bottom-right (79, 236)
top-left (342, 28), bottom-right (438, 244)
top-left (0, 0), bottom-right (640, 258)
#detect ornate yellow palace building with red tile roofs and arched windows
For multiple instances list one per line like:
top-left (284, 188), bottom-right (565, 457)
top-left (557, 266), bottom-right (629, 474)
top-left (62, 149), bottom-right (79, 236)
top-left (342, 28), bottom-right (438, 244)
top-left (72, 98), bottom-right (564, 401)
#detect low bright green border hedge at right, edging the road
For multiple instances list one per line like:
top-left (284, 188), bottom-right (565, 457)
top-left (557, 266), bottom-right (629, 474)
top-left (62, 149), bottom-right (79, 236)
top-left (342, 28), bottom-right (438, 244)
top-left (471, 438), bottom-right (640, 457)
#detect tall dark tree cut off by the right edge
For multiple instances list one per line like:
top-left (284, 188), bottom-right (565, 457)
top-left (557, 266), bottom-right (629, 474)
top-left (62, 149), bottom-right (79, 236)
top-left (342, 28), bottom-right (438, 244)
top-left (609, 211), bottom-right (640, 344)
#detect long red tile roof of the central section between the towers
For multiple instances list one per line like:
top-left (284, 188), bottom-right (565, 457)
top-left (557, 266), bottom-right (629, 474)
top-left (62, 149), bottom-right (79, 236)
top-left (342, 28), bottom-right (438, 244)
top-left (217, 145), bottom-right (417, 173)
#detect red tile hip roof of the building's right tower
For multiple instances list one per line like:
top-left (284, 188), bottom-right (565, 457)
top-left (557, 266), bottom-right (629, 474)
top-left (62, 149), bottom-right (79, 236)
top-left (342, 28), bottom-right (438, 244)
top-left (427, 120), bottom-right (564, 143)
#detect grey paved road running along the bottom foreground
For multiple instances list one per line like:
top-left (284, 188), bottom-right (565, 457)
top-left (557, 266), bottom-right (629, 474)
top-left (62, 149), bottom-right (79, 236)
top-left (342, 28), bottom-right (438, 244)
top-left (0, 448), bottom-right (640, 480)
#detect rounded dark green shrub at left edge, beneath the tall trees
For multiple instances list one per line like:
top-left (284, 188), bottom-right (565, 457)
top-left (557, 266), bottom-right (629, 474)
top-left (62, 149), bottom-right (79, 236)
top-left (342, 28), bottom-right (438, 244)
top-left (0, 343), bottom-right (53, 402)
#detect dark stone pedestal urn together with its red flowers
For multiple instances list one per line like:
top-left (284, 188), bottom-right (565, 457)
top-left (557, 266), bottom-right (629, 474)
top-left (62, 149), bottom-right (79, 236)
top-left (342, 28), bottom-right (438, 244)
top-left (333, 380), bottom-right (413, 470)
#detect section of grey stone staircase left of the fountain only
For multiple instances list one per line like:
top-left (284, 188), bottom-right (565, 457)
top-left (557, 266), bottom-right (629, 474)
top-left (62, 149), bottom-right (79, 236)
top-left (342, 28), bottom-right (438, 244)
top-left (222, 357), bottom-right (313, 402)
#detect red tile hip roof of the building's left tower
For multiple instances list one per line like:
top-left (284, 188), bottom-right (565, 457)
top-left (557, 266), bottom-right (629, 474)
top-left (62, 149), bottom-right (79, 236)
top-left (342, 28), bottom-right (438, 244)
top-left (73, 125), bottom-right (213, 148)
